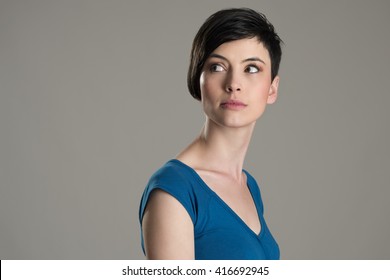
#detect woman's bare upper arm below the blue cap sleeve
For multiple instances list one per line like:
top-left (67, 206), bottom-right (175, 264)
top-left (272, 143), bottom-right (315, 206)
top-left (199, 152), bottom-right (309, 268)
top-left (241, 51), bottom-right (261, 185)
top-left (142, 189), bottom-right (195, 260)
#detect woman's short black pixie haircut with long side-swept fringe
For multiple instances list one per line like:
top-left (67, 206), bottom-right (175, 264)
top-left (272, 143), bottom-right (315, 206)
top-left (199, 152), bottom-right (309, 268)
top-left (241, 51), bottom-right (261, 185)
top-left (187, 8), bottom-right (282, 100)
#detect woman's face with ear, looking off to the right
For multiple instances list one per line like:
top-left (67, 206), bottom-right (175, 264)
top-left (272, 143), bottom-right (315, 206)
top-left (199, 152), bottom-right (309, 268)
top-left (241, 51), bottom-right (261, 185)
top-left (200, 38), bottom-right (279, 127)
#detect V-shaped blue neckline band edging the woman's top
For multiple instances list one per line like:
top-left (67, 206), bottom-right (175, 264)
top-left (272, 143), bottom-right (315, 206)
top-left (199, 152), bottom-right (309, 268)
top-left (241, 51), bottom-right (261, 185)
top-left (170, 159), bottom-right (263, 238)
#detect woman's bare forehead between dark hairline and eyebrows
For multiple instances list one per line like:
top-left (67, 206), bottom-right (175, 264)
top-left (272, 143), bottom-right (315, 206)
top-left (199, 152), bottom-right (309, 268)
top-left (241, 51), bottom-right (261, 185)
top-left (210, 37), bottom-right (271, 64)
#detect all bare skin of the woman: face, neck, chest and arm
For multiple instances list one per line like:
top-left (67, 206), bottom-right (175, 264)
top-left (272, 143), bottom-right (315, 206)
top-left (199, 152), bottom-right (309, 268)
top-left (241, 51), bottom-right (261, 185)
top-left (142, 38), bottom-right (279, 259)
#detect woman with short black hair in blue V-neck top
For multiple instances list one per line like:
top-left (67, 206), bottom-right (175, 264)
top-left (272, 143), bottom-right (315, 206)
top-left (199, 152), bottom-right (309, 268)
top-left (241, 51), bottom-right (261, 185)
top-left (139, 9), bottom-right (281, 259)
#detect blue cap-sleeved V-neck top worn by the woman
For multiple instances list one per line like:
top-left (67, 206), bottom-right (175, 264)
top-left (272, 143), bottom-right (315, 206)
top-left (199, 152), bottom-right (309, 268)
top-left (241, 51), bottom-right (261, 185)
top-left (139, 159), bottom-right (280, 260)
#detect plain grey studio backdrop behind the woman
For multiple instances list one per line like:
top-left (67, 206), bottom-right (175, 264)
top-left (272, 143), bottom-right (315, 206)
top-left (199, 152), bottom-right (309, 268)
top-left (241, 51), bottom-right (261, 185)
top-left (0, 0), bottom-right (390, 259)
